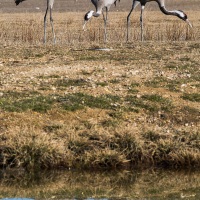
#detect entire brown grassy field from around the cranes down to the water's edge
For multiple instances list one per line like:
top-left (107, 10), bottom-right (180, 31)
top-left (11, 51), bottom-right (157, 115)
top-left (0, 1), bottom-right (200, 170)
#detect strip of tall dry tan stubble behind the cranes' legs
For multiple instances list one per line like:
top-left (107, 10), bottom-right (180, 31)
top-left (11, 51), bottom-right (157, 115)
top-left (0, 11), bottom-right (200, 46)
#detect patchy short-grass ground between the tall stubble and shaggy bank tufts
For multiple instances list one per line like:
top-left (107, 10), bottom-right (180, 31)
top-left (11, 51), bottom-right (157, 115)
top-left (0, 42), bottom-right (200, 169)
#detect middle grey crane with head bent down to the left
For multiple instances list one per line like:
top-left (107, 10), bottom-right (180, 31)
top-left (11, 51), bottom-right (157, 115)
top-left (83, 0), bottom-right (120, 41)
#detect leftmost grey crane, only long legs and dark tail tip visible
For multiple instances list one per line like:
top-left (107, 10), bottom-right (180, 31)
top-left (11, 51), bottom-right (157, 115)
top-left (15, 0), bottom-right (56, 43)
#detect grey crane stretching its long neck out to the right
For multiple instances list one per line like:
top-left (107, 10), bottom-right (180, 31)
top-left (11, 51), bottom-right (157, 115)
top-left (127, 0), bottom-right (192, 41)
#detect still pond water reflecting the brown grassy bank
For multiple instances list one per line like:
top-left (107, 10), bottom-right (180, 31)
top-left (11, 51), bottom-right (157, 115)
top-left (0, 169), bottom-right (200, 200)
